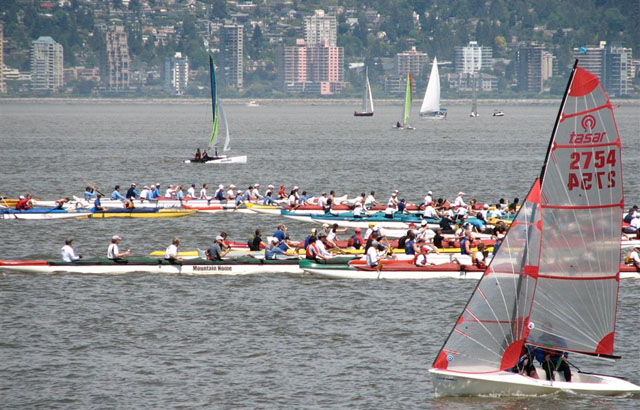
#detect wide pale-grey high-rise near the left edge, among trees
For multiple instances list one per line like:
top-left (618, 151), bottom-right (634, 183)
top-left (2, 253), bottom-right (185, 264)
top-left (31, 37), bottom-right (64, 92)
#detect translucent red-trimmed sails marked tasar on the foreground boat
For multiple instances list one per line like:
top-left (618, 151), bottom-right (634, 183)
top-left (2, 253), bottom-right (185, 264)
top-left (433, 61), bottom-right (624, 373)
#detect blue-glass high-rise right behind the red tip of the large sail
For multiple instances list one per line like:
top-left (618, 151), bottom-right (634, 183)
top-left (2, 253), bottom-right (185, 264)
top-left (573, 41), bottom-right (633, 97)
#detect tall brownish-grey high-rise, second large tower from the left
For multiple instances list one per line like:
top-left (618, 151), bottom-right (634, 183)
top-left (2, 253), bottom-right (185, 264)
top-left (100, 26), bottom-right (131, 91)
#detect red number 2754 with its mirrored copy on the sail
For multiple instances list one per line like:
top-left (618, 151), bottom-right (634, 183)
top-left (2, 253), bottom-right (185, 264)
top-left (567, 150), bottom-right (616, 191)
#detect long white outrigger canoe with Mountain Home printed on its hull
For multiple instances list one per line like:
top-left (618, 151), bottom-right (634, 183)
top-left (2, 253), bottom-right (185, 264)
top-left (0, 256), bottom-right (353, 275)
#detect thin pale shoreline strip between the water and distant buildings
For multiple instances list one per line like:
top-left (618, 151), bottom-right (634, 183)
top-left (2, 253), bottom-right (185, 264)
top-left (0, 97), bottom-right (640, 107)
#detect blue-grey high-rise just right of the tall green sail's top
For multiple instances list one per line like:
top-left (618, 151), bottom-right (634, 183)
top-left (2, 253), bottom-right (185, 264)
top-left (219, 24), bottom-right (244, 90)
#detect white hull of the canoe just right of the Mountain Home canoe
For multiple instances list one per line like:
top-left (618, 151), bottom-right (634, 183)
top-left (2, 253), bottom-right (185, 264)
top-left (303, 268), bottom-right (482, 280)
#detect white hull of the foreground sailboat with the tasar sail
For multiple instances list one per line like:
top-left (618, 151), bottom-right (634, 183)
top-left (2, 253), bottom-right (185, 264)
top-left (429, 369), bottom-right (640, 397)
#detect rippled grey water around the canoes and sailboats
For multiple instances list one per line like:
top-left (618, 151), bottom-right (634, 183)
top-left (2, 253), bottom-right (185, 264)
top-left (0, 103), bottom-right (640, 409)
